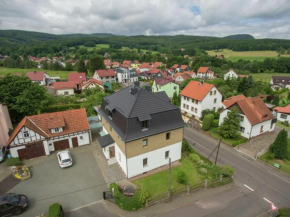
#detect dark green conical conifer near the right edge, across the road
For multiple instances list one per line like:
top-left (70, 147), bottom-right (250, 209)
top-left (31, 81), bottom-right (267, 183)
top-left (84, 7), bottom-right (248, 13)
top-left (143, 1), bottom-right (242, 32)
top-left (270, 129), bottom-right (288, 160)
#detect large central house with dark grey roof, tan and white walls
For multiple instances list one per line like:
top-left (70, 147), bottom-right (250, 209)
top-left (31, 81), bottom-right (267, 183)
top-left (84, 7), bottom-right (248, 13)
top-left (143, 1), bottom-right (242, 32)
top-left (98, 82), bottom-right (184, 178)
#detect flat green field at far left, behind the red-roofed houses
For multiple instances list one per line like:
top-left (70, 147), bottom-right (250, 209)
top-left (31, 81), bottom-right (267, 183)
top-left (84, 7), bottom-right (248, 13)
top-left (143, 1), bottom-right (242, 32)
top-left (0, 67), bottom-right (75, 79)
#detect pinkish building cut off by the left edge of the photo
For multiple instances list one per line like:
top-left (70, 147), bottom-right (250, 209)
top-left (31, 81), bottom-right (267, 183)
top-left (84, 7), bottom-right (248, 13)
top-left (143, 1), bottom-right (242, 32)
top-left (0, 103), bottom-right (13, 147)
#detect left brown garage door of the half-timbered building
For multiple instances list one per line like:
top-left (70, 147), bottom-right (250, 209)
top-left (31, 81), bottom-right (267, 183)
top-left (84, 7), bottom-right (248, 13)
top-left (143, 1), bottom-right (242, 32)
top-left (17, 142), bottom-right (45, 160)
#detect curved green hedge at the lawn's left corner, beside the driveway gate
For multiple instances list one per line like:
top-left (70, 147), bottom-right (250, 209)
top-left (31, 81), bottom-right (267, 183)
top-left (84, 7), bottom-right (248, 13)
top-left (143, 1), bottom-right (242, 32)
top-left (110, 183), bottom-right (148, 211)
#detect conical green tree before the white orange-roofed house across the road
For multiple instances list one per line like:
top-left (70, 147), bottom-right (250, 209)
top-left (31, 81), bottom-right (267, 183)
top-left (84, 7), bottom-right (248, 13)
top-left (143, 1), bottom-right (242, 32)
top-left (218, 107), bottom-right (241, 139)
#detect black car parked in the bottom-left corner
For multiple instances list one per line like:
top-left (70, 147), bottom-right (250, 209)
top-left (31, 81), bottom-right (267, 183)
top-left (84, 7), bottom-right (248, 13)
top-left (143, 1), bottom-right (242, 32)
top-left (0, 193), bottom-right (28, 217)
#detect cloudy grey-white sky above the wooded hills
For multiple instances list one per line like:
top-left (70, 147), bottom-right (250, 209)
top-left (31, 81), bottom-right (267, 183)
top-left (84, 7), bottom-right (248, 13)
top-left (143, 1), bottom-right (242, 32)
top-left (0, 0), bottom-right (290, 39)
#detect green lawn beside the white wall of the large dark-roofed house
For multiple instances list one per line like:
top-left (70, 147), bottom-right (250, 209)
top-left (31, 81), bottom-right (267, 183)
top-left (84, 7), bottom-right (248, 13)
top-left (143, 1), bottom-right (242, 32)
top-left (133, 158), bottom-right (201, 197)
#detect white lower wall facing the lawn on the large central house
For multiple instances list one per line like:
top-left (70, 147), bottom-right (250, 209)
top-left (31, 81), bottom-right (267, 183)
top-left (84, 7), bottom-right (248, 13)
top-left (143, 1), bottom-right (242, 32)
top-left (127, 142), bottom-right (181, 178)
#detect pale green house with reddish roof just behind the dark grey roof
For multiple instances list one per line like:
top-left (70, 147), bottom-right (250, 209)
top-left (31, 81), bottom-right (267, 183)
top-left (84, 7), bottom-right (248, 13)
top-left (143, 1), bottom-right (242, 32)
top-left (152, 78), bottom-right (179, 98)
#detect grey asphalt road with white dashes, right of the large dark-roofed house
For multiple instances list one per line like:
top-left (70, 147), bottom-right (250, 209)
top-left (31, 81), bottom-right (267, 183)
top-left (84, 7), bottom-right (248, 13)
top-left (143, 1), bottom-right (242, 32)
top-left (174, 128), bottom-right (290, 217)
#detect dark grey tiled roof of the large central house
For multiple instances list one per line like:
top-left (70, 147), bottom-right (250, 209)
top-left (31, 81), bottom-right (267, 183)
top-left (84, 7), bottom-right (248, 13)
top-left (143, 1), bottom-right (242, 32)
top-left (98, 87), bottom-right (184, 141)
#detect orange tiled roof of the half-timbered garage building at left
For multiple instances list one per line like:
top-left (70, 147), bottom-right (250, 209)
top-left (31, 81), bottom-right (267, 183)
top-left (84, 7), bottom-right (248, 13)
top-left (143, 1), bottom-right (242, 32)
top-left (7, 108), bottom-right (90, 145)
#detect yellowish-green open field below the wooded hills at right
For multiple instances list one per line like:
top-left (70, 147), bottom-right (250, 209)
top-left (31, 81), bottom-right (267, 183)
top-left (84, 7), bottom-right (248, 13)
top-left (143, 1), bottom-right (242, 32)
top-left (207, 49), bottom-right (290, 62)
